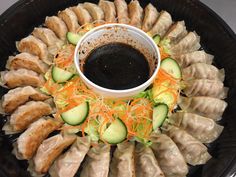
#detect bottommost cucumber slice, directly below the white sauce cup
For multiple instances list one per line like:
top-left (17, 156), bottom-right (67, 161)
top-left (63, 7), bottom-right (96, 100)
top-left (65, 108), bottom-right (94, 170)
top-left (102, 118), bottom-right (128, 144)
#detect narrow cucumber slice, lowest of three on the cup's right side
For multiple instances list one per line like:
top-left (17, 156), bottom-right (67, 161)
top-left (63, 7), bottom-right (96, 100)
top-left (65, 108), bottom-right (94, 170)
top-left (152, 103), bottom-right (169, 130)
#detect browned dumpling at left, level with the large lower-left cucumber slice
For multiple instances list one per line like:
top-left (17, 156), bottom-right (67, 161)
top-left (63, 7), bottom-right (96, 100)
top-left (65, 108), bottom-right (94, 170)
top-left (3, 101), bottom-right (53, 134)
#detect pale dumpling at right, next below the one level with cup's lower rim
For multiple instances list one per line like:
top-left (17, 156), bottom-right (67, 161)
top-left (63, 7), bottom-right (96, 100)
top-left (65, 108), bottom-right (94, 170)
top-left (179, 96), bottom-right (227, 121)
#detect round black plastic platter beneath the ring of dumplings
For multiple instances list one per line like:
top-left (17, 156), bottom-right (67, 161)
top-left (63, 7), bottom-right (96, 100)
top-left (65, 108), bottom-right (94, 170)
top-left (0, 0), bottom-right (236, 177)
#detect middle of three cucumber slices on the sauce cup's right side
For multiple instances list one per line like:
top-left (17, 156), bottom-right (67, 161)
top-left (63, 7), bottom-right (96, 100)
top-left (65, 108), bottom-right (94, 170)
top-left (161, 58), bottom-right (182, 79)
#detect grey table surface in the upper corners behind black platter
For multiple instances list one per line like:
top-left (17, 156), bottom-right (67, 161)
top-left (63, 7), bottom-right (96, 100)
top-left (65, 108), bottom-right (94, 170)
top-left (0, 0), bottom-right (236, 32)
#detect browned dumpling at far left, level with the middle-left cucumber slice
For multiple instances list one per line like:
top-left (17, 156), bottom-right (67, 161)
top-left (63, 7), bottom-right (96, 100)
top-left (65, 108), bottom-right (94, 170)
top-left (1, 69), bottom-right (45, 88)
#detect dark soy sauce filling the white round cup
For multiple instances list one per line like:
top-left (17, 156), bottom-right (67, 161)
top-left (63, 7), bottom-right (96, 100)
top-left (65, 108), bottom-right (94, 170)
top-left (83, 43), bottom-right (150, 90)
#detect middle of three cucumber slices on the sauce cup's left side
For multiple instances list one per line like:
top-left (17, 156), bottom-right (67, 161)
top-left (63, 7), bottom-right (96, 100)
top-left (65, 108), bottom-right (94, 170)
top-left (52, 66), bottom-right (74, 84)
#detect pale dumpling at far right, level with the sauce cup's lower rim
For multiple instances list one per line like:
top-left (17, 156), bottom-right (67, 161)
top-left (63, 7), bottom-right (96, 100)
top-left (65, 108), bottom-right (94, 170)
top-left (183, 79), bottom-right (228, 99)
